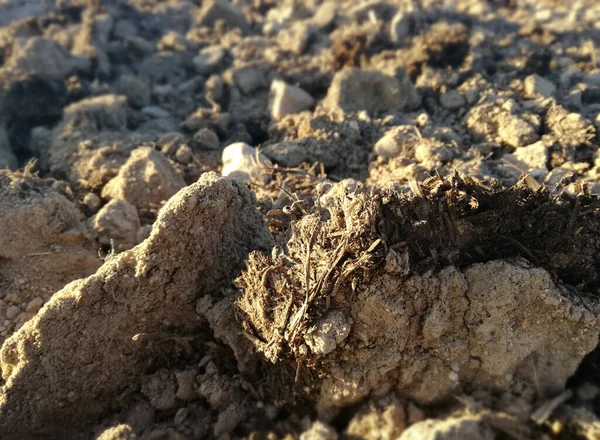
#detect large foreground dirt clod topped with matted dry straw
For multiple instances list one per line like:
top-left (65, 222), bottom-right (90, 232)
top-left (238, 177), bottom-right (600, 417)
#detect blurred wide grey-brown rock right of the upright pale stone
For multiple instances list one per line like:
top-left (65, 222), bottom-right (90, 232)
top-left (323, 67), bottom-right (420, 114)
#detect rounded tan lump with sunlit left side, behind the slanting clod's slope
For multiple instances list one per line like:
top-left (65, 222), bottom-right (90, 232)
top-left (102, 147), bottom-right (185, 210)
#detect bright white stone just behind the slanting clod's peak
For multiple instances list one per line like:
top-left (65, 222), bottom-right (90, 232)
top-left (221, 142), bottom-right (272, 184)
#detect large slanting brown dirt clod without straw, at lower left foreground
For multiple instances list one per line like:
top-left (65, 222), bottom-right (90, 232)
top-left (0, 173), bottom-right (271, 438)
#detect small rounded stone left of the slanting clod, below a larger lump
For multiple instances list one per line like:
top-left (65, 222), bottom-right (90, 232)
top-left (91, 199), bottom-right (141, 252)
